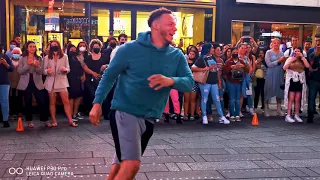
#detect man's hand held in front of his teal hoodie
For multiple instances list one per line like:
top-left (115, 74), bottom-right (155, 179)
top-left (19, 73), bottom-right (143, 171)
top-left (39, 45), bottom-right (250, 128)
top-left (148, 74), bottom-right (174, 90)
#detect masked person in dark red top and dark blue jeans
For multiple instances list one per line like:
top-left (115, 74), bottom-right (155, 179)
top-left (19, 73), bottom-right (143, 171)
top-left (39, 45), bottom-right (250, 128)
top-left (223, 48), bottom-right (249, 121)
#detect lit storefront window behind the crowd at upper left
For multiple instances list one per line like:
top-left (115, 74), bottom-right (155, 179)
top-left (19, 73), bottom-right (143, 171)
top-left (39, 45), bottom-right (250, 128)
top-left (10, 0), bottom-right (89, 52)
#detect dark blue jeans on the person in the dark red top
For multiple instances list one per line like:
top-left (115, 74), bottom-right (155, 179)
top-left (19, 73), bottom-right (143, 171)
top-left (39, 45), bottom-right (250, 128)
top-left (227, 82), bottom-right (241, 116)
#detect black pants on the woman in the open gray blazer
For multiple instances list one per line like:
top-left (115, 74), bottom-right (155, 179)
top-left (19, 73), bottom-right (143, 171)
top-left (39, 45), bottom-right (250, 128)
top-left (23, 78), bottom-right (49, 121)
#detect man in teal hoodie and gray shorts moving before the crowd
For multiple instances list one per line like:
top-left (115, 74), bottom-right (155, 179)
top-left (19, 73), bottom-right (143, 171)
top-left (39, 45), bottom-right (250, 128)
top-left (90, 8), bottom-right (194, 180)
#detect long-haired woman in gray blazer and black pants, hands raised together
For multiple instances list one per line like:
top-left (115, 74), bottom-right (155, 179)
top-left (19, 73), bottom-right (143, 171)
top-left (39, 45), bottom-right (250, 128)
top-left (17, 41), bottom-right (50, 128)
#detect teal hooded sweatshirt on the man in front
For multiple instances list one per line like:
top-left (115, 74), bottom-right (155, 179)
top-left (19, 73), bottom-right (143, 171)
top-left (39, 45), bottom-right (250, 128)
top-left (93, 32), bottom-right (194, 119)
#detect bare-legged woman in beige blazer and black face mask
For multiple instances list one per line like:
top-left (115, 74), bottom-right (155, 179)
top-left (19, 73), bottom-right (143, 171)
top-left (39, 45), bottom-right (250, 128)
top-left (44, 40), bottom-right (78, 127)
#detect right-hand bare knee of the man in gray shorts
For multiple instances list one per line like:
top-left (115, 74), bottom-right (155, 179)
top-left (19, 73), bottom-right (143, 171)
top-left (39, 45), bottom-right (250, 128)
top-left (114, 160), bottom-right (140, 180)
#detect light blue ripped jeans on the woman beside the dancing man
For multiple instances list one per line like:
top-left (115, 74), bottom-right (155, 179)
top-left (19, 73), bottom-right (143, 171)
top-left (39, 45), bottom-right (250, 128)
top-left (199, 84), bottom-right (224, 117)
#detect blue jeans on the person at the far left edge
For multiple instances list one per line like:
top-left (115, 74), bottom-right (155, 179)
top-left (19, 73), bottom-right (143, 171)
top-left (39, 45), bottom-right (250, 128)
top-left (0, 84), bottom-right (10, 121)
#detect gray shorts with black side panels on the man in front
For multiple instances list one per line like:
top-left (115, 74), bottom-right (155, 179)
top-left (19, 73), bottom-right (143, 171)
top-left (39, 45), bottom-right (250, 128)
top-left (110, 110), bottom-right (154, 164)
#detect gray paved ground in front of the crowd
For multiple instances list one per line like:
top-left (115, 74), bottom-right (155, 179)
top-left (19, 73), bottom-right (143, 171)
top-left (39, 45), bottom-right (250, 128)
top-left (0, 111), bottom-right (320, 180)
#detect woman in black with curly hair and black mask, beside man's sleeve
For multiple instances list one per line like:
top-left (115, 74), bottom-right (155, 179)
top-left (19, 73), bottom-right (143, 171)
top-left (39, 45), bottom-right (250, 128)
top-left (83, 39), bottom-right (109, 115)
